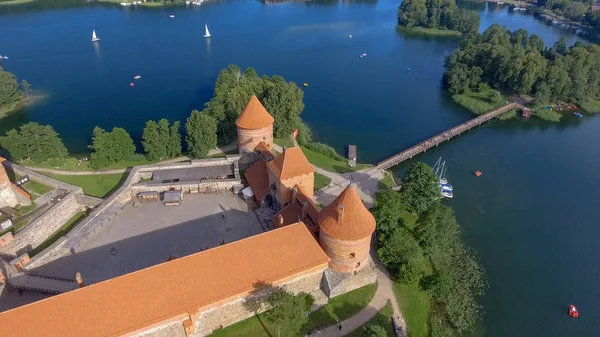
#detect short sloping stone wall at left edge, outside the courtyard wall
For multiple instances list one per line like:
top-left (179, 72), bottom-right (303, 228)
top-left (0, 192), bottom-right (84, 258)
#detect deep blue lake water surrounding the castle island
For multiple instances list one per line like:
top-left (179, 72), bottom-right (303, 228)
top-left (0, 0), bottom-right (600, 337)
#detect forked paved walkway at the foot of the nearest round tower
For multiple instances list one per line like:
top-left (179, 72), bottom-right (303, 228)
top-left (310, 252), bottom-right (406, 337)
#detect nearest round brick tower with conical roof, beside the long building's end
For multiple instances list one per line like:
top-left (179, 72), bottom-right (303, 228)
top-left (319, 185), bottom-right (375, 273)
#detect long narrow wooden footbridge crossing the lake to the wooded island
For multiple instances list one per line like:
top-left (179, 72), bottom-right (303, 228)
top-left (377, 103), bottom-right (523, 170)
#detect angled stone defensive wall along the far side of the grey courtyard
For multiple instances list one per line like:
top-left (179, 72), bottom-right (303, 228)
top-left (25, 155), bottom-right (241, 270)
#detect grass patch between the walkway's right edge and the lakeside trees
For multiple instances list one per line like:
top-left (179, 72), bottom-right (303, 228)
top-left (394, 282), bottom-right (430, 337)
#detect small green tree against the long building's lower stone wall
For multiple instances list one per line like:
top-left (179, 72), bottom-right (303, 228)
top-left (265, 288), bottom-right (310, 336)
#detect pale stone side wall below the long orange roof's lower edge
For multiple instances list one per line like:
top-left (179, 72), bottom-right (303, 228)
top-left (193, 269), bottom-right (324, 337)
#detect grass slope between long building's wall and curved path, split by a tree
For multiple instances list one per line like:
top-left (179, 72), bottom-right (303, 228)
top-left (210, 284), bottom-right (377, 337)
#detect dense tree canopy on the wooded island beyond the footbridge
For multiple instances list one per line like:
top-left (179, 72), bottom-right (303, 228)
top-left (444, 24), bottom-right (600, 104)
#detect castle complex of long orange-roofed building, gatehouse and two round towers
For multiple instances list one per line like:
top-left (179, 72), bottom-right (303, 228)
top-left (0, 96), bottom-right (376, 337)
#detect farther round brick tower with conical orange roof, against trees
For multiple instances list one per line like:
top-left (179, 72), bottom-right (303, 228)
top-left (235, 95), bottom-right (275, 154)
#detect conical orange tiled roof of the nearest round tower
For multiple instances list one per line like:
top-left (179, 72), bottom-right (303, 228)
top-left (319, 185), bottom-right (375, 241)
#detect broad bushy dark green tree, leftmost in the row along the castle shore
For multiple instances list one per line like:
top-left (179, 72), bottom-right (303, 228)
top-left (0, 122), bottom-right (68, 162)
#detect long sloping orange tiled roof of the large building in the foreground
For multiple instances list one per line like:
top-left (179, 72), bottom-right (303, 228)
top-left (0, 223), bottom-right (329, 337)
